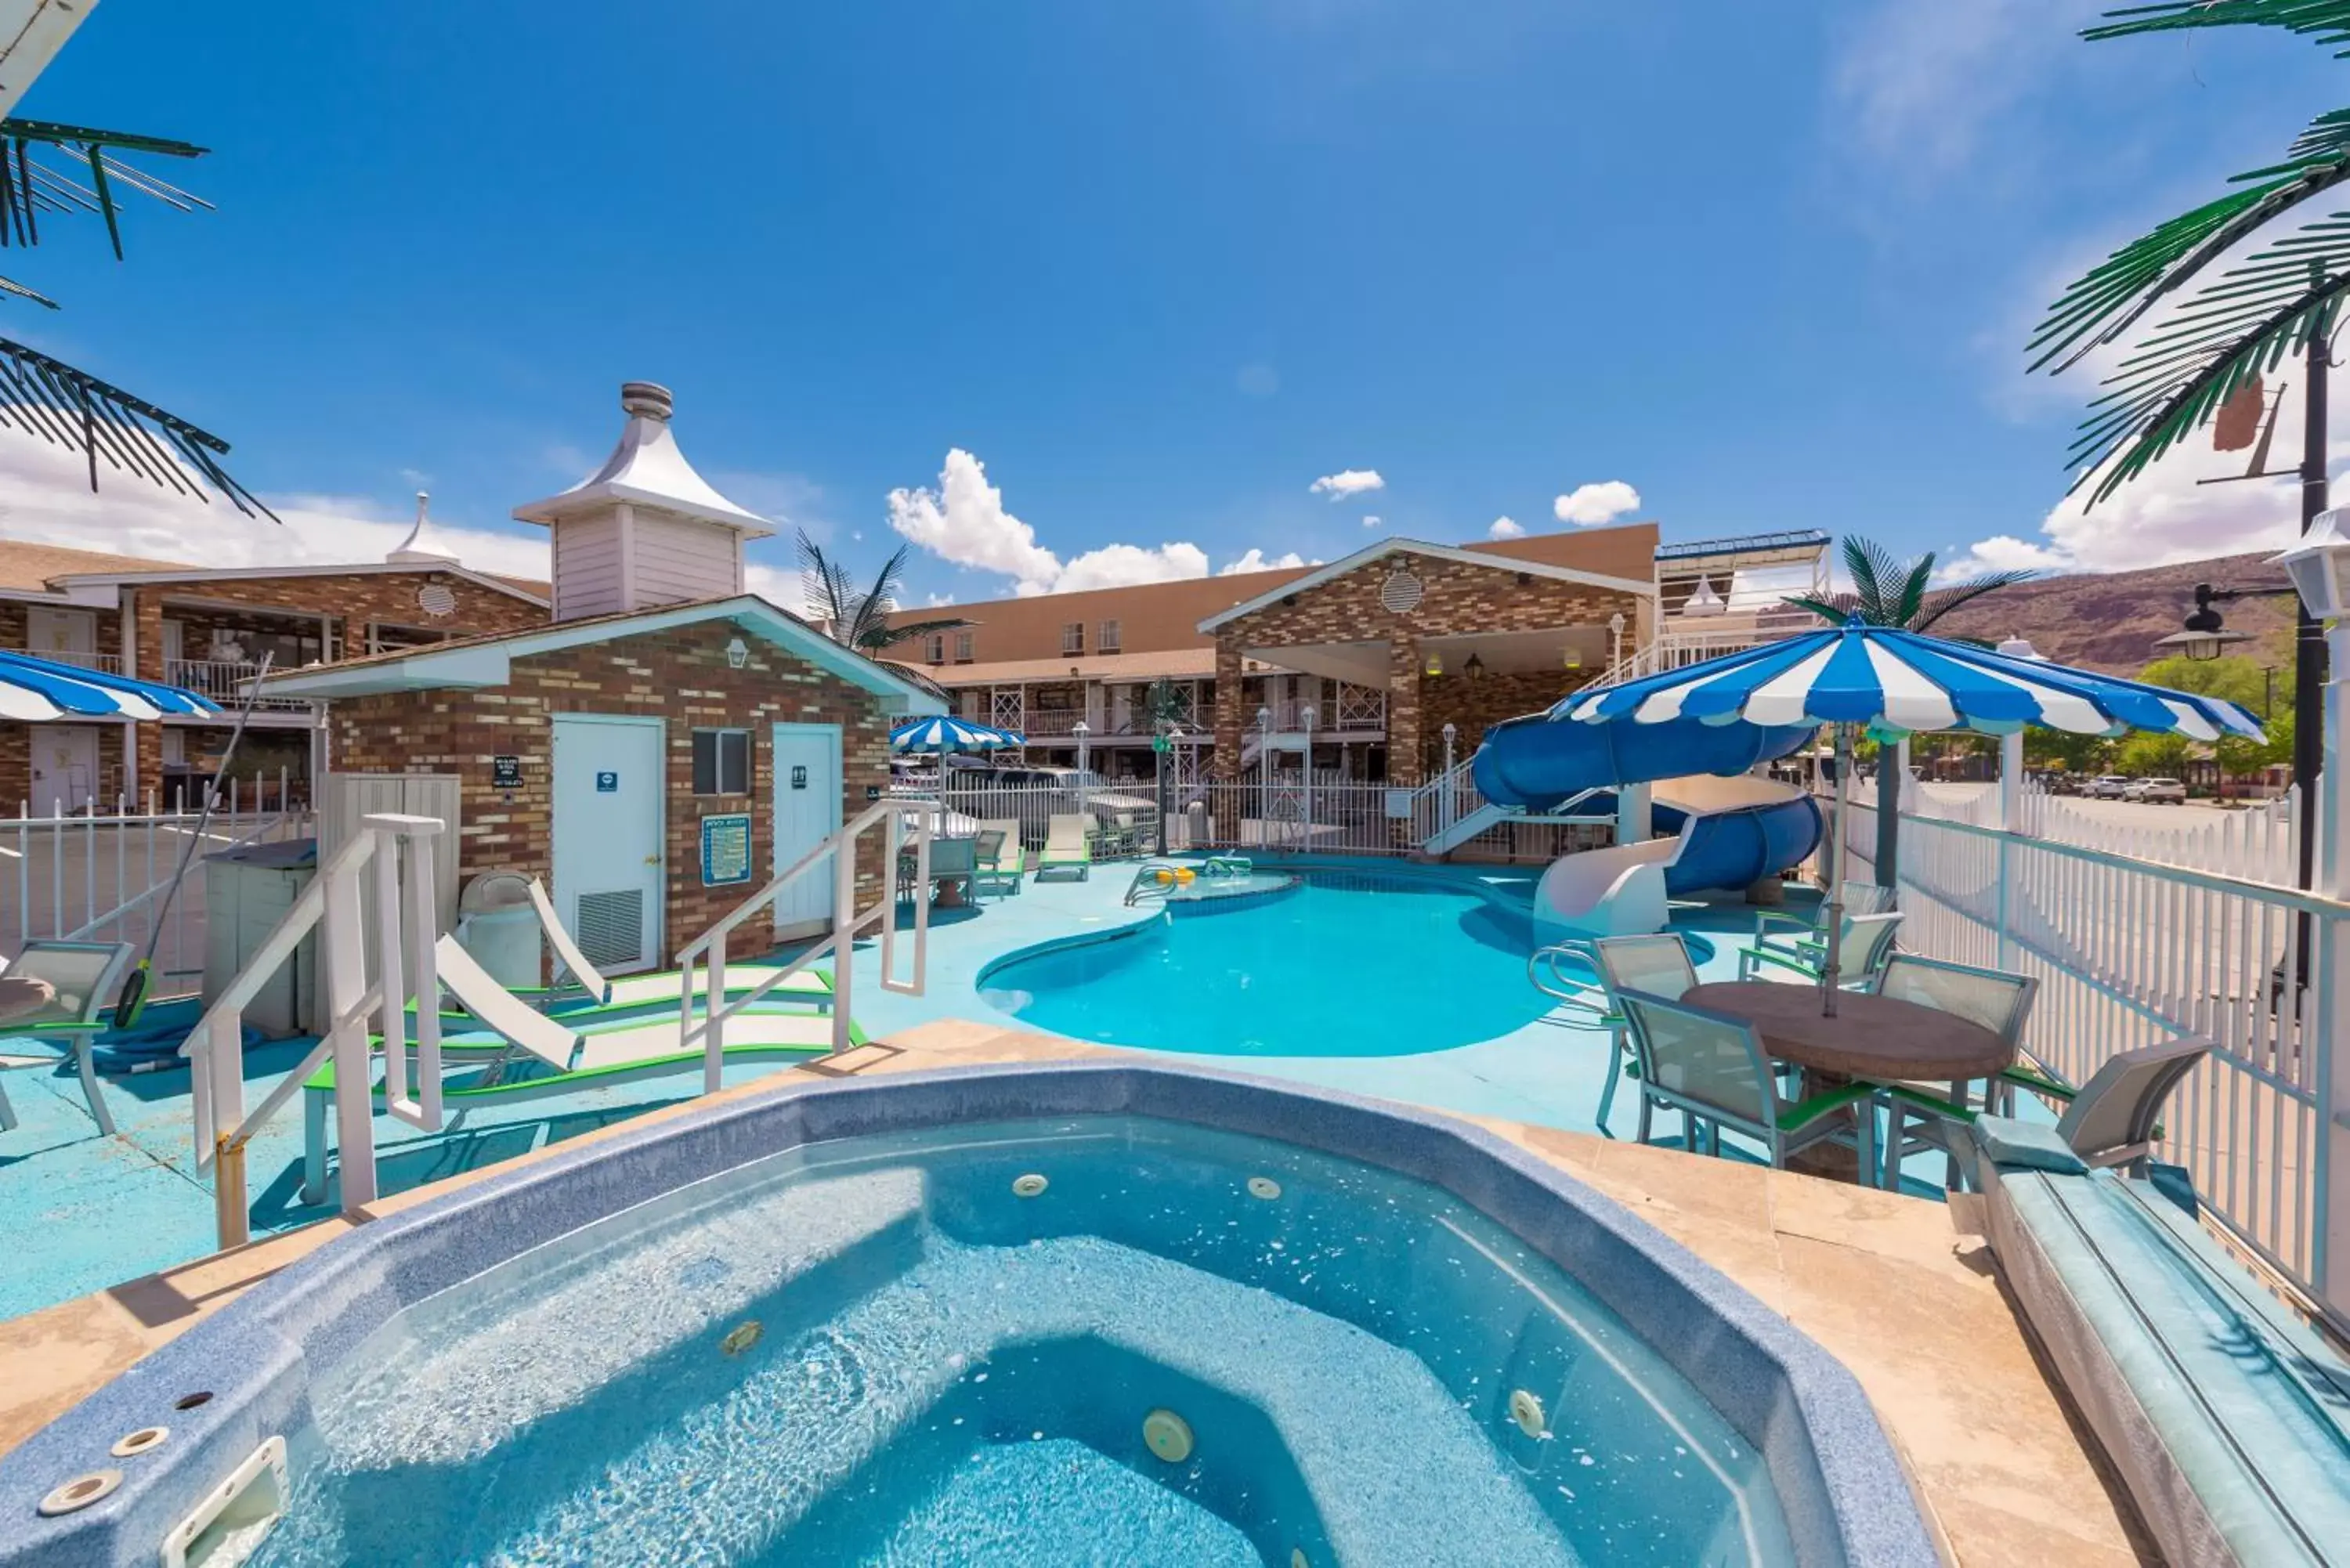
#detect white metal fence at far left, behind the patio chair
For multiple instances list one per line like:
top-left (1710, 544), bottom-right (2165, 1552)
top-left (0, 773), bottom-right (313, 995)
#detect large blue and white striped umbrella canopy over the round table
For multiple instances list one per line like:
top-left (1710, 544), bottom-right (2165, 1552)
top-left (1551, 620), bottom-right (2261, 740)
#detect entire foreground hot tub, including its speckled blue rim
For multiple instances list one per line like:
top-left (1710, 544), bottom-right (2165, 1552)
top-left (0, 1065), bottom-right (1932, 1568)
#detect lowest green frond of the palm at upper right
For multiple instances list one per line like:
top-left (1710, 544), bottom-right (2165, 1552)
top-left (2068, 214), bottom-right (2350, 505)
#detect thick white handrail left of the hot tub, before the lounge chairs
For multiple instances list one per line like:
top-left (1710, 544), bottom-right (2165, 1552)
top-left (179, 816), bottom-right (442, 1248)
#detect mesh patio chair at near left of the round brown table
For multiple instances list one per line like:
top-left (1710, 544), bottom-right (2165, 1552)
top-left (1617, 990), bottom-right (1878, 1185)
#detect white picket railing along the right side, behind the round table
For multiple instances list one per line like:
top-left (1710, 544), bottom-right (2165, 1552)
top-left (1845, 804), bottom-right (2350, 1324)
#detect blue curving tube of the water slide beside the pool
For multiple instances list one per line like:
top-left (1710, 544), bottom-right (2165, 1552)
top-left (1471, 714), bottom-right (1824, 896)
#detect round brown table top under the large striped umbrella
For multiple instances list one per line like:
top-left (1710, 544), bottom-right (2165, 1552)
top-left (1683, 981), bottom-right (2016, 1084)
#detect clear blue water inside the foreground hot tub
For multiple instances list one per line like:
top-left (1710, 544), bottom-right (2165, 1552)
top-left (254, 1117), bottom-right (1791, 1568)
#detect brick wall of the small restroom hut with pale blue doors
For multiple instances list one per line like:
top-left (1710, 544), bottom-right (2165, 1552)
top-left (329, 620), bottom-right (888, 964)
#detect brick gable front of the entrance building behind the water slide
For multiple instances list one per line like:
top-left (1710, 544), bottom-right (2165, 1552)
top-left (1215, 552), bottom-right (1640, 786)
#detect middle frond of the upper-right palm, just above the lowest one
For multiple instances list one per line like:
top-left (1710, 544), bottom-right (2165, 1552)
top-left (2023, 108), bottom-right (2350, 374)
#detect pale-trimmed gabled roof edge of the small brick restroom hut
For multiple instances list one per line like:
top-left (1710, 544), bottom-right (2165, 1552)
top-left (266, 592), bottom-right (947, 714)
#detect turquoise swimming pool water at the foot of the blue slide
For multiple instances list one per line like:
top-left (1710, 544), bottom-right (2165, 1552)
top-left (980, 868), bottom-right (1711, 1056)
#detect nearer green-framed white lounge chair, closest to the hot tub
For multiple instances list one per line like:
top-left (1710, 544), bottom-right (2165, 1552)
top-left (301, 936), bottom-right (867, 1204)
